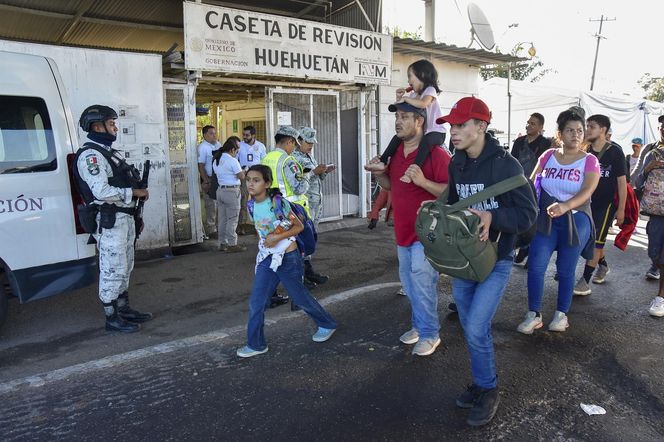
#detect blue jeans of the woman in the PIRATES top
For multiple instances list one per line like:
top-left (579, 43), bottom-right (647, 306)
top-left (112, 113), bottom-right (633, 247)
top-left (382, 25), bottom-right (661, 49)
top-left (528, 212), bottom-right (591, 313)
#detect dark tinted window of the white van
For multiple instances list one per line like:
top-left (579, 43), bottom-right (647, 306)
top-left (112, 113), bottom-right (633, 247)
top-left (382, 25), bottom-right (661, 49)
top-left (0, 95), bottom-right (58, 174)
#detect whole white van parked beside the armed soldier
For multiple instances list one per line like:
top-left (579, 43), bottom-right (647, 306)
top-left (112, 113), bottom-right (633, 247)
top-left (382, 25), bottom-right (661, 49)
top-left (0, 51), bottom-right (97, 325)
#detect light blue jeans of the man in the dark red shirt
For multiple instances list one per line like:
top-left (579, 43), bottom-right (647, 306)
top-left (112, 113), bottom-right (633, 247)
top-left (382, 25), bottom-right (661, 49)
top-left (397, 242), bottom-right (440, 339)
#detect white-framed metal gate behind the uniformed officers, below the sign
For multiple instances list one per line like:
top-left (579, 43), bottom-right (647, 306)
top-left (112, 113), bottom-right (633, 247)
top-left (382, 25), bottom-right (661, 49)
top-left (266, 88), bottom-right (343, 221)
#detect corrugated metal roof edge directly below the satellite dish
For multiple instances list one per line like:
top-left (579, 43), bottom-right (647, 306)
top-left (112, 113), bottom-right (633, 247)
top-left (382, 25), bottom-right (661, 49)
top-left (393, 37), bottom-right (527, 66)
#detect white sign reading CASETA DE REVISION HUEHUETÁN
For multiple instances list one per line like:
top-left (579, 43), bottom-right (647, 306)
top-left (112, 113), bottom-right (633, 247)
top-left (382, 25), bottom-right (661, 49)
top-left (184, 2), bottom-right (392, 84)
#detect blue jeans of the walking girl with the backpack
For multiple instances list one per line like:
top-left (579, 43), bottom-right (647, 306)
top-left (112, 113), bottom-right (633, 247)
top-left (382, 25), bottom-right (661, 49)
top-left (247, 250), bottom-right (337, 350)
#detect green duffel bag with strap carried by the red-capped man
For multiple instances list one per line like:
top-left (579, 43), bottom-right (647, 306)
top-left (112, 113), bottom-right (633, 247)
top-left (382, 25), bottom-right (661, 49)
top-left (415, 175), bottom-right (528, 282)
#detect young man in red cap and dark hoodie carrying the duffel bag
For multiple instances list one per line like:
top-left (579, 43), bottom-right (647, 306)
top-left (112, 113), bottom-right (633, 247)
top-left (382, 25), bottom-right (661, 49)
top-left (437, 97), bottom-right (537, 426)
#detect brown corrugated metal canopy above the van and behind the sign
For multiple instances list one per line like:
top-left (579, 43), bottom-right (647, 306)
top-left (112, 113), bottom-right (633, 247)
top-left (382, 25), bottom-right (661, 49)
top-left (0, 0), bottom-right (376, 53)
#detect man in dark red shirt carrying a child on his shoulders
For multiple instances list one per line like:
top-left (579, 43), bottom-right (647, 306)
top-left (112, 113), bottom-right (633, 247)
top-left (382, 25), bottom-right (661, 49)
top-left (365, 103), bottom-right (450, 356)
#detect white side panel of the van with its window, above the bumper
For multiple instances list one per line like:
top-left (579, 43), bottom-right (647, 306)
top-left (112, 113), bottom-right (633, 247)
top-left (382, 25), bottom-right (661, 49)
top-left (0, 53), bottom-right (79, 290)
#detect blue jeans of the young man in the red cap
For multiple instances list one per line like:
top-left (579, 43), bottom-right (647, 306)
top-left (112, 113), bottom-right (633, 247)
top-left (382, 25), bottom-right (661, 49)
top-left (452, 255), bottom-right (512, 388)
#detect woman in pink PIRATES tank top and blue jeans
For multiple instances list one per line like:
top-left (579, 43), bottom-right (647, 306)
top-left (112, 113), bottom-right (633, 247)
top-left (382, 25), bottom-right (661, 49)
top-left (517, 109), bottom-right (599, 335)
